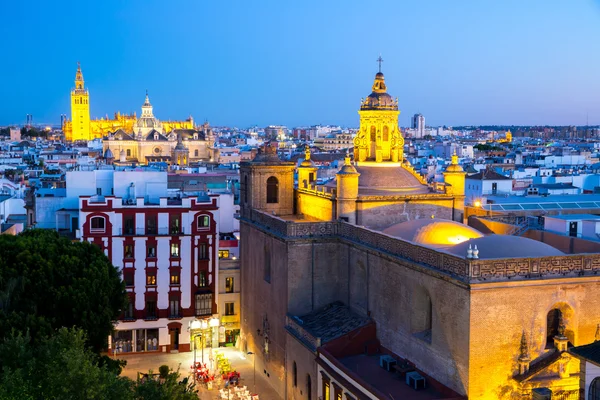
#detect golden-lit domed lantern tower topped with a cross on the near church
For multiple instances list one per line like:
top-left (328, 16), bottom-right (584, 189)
top-left (354, 57), bottom-right (404, 163)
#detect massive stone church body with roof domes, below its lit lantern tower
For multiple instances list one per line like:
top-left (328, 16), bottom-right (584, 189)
top-left (240, 69), bottom-right (600, 400)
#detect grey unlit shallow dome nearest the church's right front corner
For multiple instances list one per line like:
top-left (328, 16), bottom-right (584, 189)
top-left (448, 235), bottom-right (564, 259)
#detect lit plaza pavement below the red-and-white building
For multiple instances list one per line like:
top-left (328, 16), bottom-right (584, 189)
top-left (118, 347), bottom-right (281, 400)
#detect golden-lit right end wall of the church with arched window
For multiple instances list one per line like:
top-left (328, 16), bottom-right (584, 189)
top-left (469, 277), bottom-right (600, 399)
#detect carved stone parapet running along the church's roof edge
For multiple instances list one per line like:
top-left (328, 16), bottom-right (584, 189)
top-left (242, 210), bottom-right (600, 283)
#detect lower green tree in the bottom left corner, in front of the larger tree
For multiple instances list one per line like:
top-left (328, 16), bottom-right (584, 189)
top-left (0, 328), bottom-right (134, 400)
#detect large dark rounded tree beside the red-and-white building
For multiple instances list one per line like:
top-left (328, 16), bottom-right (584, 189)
top-left (0, 229), bottom-right (127, 352)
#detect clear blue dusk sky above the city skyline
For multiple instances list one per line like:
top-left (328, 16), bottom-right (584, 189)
top-left (0, 0), bottom-right (600, 127)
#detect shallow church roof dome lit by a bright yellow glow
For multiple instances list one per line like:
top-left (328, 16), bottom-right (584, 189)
top-left (383, 218), bottom-right (483, 247)
